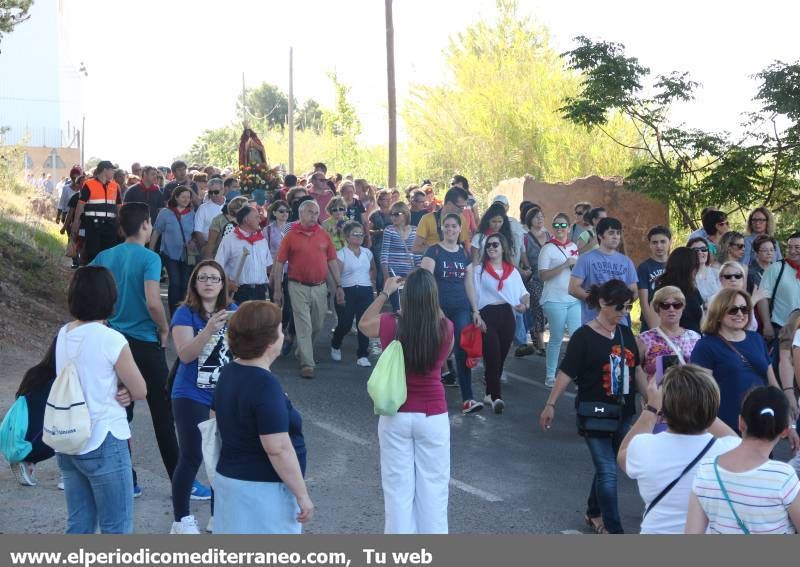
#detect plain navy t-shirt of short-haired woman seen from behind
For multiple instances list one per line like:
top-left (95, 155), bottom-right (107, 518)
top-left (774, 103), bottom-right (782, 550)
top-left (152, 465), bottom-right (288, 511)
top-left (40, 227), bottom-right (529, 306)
top-left (212, 362), bottom-right (306, 482)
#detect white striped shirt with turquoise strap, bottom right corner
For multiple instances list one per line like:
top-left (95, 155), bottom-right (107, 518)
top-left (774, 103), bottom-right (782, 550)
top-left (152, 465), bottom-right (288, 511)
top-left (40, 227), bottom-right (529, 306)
top-left (692, 459), bottom-right (800, 534)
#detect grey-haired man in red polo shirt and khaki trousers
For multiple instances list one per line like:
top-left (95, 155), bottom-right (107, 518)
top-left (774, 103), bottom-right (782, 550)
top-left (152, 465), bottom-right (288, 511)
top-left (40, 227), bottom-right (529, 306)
top-left (272, 197), bottom-right (344, 378)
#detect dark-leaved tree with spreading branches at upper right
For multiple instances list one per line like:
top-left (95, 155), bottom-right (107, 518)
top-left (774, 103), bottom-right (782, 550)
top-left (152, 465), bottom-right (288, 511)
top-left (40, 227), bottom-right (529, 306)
top-left (561, 36), bottom-right (800, 228)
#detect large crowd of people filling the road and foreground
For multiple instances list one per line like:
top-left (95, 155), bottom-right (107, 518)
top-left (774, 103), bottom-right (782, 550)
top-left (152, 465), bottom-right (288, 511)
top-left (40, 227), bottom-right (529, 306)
top-left (4, 161), bottom-right (800, 534)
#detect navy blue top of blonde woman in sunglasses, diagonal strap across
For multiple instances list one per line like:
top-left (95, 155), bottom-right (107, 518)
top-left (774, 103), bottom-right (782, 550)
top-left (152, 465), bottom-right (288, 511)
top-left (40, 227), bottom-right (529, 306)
top-left (692, 331), bottom-right (769, 431)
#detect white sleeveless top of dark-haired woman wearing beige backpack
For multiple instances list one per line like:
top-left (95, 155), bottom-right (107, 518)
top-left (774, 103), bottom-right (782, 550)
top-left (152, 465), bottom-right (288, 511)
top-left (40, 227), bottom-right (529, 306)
top-left (56, 323), bottom-right (131, 455)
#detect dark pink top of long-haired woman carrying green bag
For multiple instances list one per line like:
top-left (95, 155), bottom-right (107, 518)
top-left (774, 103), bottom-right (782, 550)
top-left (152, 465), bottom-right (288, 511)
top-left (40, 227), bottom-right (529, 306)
top-left (379, 313), bottom-right (453, 415)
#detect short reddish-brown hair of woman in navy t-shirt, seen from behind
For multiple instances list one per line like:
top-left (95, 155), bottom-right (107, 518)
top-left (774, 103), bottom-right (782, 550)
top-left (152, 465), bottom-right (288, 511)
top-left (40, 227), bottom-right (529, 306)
top-left (228, 301), bottom-right (283, 360)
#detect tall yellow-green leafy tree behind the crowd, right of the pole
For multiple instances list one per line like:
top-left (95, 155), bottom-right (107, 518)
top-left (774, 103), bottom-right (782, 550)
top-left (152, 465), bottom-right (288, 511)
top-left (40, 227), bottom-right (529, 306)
top-left (403, 0), bottom-right (636, 192)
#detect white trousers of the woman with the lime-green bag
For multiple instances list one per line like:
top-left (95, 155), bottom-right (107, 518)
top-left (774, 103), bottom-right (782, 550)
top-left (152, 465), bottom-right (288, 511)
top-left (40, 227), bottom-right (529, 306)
top-left (378, 412), bottom-right (450, 534)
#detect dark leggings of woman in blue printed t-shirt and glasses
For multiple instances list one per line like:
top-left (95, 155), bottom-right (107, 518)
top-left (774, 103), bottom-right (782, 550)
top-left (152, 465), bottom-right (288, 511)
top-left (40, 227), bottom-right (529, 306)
top-left (172, 398), bottom-right (214, 522)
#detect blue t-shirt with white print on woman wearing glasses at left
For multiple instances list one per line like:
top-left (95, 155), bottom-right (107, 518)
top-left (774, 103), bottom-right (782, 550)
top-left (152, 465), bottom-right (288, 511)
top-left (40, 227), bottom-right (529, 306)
top-left (170, 304), bottom-right (236, 407)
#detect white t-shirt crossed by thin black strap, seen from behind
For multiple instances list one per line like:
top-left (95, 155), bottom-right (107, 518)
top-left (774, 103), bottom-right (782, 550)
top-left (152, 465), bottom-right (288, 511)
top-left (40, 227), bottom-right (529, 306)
top-left (625, 431), bottom-right (742, 534)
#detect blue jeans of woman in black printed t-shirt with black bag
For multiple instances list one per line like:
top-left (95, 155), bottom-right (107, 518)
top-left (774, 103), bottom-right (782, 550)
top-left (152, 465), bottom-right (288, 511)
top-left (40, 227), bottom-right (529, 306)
top-left (584, 416), bottom-right (633, 534)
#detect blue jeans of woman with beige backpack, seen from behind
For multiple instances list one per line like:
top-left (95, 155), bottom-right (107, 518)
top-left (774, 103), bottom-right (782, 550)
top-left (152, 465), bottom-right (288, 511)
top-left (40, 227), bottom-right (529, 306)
top-left (58, 433), bottom-right (133, 534)
